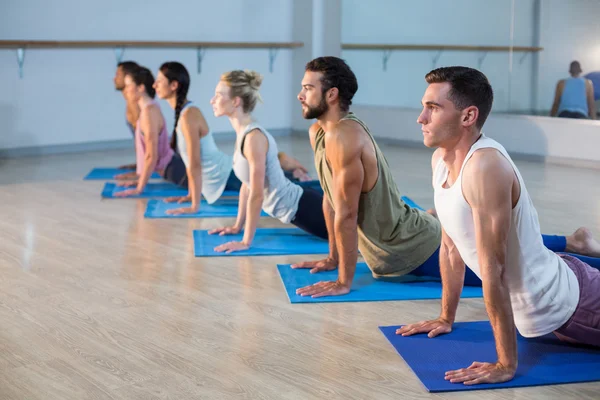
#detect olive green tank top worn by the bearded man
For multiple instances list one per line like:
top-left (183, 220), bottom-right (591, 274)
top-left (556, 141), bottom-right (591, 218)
top-left (315, 113), bottom-right (442, 276)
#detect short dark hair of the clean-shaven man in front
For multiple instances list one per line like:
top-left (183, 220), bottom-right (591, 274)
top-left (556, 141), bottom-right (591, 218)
top-left (425, 67), bottom-right (494, 129)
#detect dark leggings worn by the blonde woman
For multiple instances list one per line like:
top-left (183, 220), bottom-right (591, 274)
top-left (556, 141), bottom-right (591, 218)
top-left (292, 187), bottom-right (328, 240)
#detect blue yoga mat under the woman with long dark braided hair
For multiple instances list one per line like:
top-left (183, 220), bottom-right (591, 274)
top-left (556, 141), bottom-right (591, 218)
top-left (144, 199), bottom-right (268, 218)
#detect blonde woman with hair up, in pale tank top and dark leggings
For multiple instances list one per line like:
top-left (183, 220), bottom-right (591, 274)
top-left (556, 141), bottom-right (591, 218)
top-left (209, 70), bottom-right (327, 253)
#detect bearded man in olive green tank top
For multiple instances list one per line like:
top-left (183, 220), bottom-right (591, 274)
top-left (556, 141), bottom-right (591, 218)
top-left (292, 57), bottom-right (441, 297)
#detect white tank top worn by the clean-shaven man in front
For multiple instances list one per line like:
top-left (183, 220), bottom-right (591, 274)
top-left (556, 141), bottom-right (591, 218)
top-left (433, 135), bottom-right (579, 337)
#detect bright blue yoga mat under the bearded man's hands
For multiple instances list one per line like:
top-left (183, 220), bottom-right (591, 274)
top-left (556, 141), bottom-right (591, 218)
top-left (277, 263), bottom-right (482, 303)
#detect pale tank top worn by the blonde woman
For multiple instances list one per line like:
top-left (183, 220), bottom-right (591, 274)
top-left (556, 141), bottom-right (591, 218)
top-left (233, 122), bottom-right (303, 224)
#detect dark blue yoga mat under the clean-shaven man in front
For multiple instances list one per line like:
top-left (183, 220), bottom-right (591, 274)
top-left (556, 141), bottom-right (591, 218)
top-left (379, 321), bottom-right (600, 392)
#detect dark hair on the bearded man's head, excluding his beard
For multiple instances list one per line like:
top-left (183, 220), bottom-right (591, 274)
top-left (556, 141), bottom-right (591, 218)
top-left (306, 57), bottom-right (358, 111)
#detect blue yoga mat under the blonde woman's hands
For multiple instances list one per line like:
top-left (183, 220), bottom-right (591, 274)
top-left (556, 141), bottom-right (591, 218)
top-left (194, 228), bottom-right (329, 257)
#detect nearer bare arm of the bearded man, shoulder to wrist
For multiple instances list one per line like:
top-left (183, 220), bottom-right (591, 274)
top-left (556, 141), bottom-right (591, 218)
top-left (325, 122), bottom-right (364, 288)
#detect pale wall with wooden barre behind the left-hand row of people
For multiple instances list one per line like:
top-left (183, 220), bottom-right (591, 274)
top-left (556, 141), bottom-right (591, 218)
top-left (0, 0), bottom-right (294, 149)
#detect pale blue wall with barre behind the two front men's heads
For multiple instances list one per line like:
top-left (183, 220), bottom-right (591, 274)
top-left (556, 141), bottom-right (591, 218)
top-left (342, 0), bottom-right (535, 111)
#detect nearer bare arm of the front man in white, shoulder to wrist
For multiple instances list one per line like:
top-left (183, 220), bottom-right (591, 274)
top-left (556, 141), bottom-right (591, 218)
top-left (462, 149), bottom-right (520, 369)
